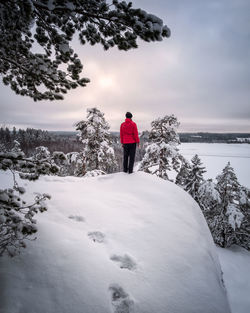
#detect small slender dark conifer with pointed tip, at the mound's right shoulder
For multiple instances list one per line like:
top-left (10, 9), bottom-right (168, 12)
top-left (184, 154), bottom-right (206, 201)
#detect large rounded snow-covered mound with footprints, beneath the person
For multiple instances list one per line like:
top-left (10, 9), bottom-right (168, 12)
top-left (0, 172), bottom-right (230, 313)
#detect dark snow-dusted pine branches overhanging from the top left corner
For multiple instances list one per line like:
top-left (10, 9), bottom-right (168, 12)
top-left (0, 0), bottom-right (170, 101)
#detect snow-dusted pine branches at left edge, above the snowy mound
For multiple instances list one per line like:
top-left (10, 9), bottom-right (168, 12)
top-left (0, 151), bottom-right (57, 256)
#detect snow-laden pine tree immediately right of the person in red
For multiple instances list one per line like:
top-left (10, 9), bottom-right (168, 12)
top-left (139, 115), bottom-right (181, 179)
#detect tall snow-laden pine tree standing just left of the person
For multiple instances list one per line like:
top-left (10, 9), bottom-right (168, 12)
top-left (76, 108), bottom-right (117, 176)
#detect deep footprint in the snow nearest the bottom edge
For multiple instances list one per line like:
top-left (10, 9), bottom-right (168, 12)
top-left (109, 284), bottom-right (134, 313)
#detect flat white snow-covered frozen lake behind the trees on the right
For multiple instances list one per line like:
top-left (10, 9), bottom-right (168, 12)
top-left (179, 143), bottom-right (250, 188)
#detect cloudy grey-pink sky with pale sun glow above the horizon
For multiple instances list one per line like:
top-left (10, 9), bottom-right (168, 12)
top-left (0, 0), bottom-right (250, 132)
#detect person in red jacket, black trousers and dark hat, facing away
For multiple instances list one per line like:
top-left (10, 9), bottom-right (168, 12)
top-left (120, 112), bottom-right (140, 174)
